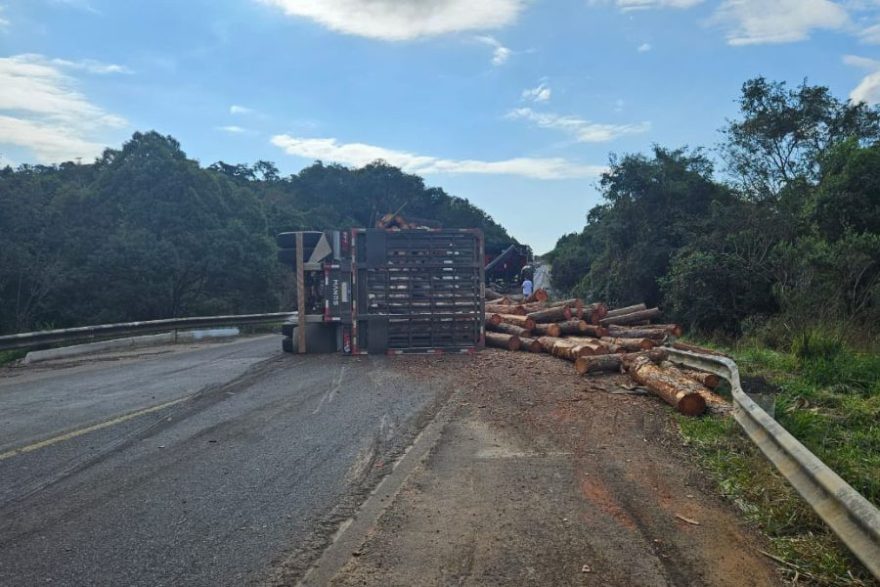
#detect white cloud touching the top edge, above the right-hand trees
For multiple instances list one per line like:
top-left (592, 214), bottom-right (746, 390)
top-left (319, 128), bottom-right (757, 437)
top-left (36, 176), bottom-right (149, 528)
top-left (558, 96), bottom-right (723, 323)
top-left (712, 0), bottom-right (849, 45)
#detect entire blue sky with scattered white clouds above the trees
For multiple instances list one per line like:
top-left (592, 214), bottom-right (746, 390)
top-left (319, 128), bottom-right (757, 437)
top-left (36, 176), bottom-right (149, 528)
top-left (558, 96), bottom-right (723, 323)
top-left (0, 0), bottom-right (880, 253)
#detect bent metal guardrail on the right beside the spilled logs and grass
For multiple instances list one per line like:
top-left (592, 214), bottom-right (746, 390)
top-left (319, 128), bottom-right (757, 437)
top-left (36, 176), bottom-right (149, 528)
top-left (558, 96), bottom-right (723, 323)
top-left (668, 349), bottom-right (880, 579)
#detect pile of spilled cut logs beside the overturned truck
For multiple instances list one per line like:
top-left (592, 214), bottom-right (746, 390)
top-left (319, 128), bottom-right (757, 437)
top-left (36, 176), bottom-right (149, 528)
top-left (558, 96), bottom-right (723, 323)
top-left (486, 298), bottom-right (732, 416)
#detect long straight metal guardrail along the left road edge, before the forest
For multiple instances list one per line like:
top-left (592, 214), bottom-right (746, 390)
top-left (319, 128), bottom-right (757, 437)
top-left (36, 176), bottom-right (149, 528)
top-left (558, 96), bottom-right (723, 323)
top-left (0, 312), bottom-right (296, 351)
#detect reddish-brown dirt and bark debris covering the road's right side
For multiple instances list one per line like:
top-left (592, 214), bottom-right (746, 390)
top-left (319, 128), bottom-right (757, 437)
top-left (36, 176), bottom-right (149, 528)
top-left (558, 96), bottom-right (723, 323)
top-left (324, 350), bottom-right (782, 587)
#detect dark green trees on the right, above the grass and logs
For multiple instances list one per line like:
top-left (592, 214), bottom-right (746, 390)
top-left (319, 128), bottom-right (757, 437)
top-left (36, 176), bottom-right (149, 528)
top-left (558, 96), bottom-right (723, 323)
top-left (548, 78), bottom-right (880, 346)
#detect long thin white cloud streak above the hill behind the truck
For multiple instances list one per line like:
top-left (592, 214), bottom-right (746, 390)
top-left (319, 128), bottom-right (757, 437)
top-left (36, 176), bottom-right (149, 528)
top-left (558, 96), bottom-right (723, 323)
top-left (271, 135), bottom-right (606, 179)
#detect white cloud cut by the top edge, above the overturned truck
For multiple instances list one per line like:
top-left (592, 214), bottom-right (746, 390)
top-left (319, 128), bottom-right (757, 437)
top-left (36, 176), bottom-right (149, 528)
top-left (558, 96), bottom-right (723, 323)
top-left (258, 0), bottom-right (525, 41)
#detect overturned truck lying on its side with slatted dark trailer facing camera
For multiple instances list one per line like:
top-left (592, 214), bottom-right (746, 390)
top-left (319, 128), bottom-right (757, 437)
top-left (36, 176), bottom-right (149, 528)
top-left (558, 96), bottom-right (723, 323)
top-left (276, 227), bottom-right (485, 355)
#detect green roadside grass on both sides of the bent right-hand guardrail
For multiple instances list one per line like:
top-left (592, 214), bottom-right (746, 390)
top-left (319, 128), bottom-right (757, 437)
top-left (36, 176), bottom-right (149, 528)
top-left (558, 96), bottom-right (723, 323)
top-left (679, 333), bottom-right (880, 585)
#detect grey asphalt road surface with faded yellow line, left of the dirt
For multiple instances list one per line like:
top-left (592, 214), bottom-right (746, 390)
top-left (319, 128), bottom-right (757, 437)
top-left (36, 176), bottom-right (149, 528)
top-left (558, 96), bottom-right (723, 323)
top-left (0, 336), bottom-right (444, 585)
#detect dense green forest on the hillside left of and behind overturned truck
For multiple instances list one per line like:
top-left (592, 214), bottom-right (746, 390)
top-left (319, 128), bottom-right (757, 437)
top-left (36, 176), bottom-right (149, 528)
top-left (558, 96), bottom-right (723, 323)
top-left (0, 132), bottom-right (514, 334)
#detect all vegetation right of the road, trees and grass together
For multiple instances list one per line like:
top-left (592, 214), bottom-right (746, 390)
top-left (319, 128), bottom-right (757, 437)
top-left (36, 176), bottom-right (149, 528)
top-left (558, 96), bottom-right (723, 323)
top-left (548, 78), bottom-right (880, 585)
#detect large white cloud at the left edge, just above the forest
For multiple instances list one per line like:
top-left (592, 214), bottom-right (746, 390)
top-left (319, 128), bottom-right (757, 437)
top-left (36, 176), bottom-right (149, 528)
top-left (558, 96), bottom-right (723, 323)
top-left (0, 54), bottom-right (127, 163)
